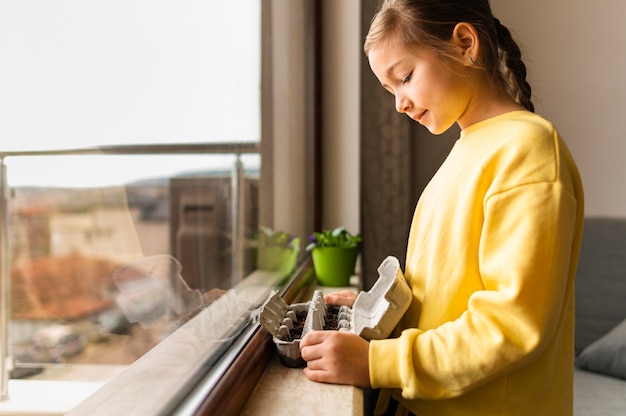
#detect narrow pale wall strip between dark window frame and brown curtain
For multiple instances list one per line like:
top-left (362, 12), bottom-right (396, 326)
top-left (322, 0), bottom-right (363, 232)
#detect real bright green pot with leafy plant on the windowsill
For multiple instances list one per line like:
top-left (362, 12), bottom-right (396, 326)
top-left (306, 227), bottom-right (363, 287)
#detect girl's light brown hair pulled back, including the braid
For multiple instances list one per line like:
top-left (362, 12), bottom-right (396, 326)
top-left (364, 0), bottom-right (535, 112)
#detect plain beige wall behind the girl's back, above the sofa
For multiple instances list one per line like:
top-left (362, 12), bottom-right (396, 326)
top-left (491, 0), bottom-right (626, 216)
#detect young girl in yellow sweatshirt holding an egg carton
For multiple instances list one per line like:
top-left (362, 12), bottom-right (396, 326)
top-left (300, 0), bottom-right (583, 416)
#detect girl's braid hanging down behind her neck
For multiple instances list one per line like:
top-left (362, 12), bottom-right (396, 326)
top-left (495, 19), bottom-right (535, 112)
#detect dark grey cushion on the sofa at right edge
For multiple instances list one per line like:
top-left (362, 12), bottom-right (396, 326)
top-left (576, 319), bottom-right (626, 379)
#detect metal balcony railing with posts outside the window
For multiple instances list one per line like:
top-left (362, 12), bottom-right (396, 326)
top-left (0, 142), bottom-right (260, 400)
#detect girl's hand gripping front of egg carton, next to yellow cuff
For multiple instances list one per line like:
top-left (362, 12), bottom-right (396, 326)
top-left (300, 331), bottom-right (370, 388)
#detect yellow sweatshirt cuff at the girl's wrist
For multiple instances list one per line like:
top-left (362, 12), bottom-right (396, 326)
top-left (369, 338), bottom-right (402, 388)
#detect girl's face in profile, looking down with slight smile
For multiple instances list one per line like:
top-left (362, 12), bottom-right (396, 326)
top-left (369, 41), bottom-right (472, 134)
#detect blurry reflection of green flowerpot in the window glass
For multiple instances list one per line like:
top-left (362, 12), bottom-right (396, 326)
top-left (257, 227), bottom-right (300, 275)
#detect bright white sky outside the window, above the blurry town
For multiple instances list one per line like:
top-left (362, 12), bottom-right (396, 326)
top-left (0, 0), bottom-right (260, 186)
